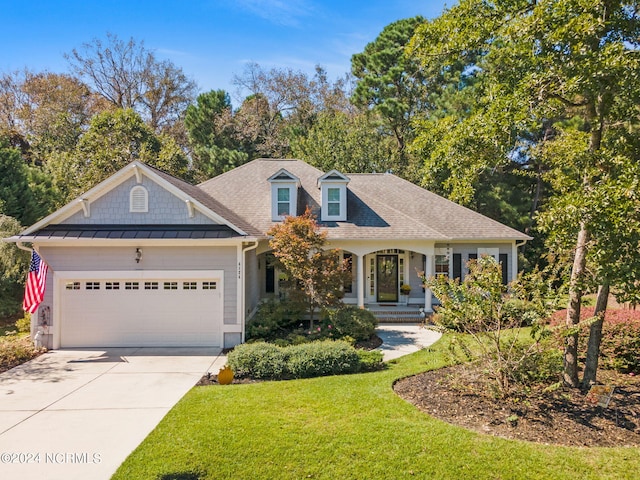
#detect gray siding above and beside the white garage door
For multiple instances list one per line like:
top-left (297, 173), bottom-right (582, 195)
top-left (40, 246), bottom-right (238, 325)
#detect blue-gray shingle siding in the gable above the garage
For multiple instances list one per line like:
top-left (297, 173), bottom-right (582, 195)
top-left (63, 176), bottom-right (215, 225)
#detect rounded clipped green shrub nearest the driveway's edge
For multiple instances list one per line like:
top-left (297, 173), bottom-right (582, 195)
top-left (227, 342), bottom-right (286, 379)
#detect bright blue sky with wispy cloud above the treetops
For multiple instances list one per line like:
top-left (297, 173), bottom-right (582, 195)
top-left (0, 0), bottom-right (454, 104)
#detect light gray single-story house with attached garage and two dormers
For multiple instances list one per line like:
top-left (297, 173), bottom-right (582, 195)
top-left (7, 159), bottom-right (530, 348)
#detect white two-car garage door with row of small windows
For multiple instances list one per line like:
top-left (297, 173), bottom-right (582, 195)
top-left (59, 272), bottom-right (224, 347)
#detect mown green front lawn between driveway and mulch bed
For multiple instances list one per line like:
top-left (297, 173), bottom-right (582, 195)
top-left (114, 339), bottom-right (640, 480)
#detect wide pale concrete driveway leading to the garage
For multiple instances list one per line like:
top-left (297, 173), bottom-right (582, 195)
top-left (0, 348), bottom-right (226, 480)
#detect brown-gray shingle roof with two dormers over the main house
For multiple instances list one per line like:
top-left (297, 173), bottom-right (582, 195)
top-left (199, 159), bottom-right (530, 241)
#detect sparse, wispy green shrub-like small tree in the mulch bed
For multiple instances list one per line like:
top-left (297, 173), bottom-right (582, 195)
top-left (420, 256), bottom-right (561, 397)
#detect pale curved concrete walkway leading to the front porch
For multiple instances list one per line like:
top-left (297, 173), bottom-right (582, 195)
top-left (376, 323), bottom-right (442, 362)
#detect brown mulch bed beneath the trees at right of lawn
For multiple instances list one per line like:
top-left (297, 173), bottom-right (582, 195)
top-left (394, 365), bottom-right (640, 447)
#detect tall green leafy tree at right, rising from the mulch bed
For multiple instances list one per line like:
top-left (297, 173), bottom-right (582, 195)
top-left (412, 0), bottom-right (640, 386)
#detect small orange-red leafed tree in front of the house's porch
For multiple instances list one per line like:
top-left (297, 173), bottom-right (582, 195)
top-left (267, 208), bottom-right (350, 328)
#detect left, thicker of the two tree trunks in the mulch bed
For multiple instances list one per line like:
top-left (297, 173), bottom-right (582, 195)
top-left (563, 222), bottom-right (589, 388)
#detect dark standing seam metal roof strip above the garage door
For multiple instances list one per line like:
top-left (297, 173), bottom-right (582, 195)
top-left (30, 224), bottom-right (241, 239)
